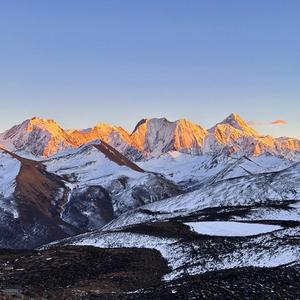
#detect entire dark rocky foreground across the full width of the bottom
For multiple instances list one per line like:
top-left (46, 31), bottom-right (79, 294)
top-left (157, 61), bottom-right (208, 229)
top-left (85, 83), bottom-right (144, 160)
top-left (0, 246), bottom-right (300, 300)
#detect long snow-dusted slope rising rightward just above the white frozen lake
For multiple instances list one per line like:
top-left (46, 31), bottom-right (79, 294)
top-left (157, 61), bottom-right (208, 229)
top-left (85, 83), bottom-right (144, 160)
top-left (100, 163), bottom-right (300, 230)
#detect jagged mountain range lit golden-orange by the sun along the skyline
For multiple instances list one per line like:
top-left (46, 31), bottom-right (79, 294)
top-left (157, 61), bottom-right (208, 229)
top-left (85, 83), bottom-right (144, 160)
top-left (0, 113), bottom-right (300, 160)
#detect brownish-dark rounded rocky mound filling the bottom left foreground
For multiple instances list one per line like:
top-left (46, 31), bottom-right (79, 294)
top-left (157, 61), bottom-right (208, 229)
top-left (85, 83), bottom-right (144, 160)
top-left (0, 246), bottom-right (169, 299)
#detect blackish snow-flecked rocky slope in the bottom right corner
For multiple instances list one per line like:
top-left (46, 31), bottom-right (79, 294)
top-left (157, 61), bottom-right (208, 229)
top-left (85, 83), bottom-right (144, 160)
top-left (122, 266), bottom-right (300, 300)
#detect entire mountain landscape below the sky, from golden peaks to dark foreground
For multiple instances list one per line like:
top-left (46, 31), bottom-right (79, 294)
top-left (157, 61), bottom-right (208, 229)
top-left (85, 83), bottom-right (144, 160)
top-left (0, 113), bottom-right (300, 299)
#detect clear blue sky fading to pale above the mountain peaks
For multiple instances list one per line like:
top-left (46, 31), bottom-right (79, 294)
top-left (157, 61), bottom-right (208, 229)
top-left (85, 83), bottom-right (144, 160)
top-left (0, 0), bottom-right (300, 138)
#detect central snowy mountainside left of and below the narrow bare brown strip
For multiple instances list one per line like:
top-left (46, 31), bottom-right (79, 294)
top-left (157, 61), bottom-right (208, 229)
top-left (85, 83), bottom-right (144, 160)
top-left (44, 142), bottom-right (181, 215)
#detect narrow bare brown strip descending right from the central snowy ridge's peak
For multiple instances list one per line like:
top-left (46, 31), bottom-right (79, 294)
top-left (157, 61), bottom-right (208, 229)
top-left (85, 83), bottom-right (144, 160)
top-left (94, 141), bottom-right (145, 173)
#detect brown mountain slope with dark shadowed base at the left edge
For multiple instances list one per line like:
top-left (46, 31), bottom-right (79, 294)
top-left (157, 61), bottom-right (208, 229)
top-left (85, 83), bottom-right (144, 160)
top-left (0, 150), bottom-right (81, 248)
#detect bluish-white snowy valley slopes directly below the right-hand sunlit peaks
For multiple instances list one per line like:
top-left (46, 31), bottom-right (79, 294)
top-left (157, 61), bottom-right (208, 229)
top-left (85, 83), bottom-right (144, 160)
top-left (138, 151), bottom-right (294, 186)
